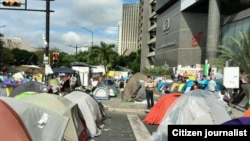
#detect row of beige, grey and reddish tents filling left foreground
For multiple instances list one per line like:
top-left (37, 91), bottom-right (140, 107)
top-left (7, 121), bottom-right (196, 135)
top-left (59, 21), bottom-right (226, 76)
top-left (0, 81), bottom-right (105, 141)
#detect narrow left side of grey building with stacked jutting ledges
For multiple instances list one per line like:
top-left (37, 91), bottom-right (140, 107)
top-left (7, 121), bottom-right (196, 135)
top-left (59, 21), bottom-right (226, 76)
top-left (138, 0), bottom-right (157, 71)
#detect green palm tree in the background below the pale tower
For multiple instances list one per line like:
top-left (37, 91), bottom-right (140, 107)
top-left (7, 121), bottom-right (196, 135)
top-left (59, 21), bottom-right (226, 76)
top-left (91, 42), bottom-right (118, 77)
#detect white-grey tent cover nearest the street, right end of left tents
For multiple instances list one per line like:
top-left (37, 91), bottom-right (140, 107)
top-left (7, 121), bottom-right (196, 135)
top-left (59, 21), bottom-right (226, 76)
top-left (65, 91), bottom-right (104, 137)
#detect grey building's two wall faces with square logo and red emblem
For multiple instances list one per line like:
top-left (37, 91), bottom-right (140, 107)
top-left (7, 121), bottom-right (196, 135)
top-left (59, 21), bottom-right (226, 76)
top-left (155, 1), bottom-right (208, 67)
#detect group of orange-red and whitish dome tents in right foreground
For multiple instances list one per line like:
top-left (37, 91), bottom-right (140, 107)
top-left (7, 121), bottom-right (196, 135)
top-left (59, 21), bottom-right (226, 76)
top-left (143, 89), bottom-right (250, 141)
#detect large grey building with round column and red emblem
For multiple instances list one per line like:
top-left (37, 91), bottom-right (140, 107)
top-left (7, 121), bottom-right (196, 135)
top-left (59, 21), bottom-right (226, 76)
top-left (139, 0), bottom-right (250, 67)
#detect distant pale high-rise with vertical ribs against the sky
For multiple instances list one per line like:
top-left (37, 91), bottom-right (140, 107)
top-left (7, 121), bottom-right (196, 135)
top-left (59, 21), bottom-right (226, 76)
top-left (119, 3), bottom-right (139, 55)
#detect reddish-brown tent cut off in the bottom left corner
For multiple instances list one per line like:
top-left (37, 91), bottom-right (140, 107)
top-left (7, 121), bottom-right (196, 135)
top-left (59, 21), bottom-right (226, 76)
top-left (0, 100), bottom-right (31, 141)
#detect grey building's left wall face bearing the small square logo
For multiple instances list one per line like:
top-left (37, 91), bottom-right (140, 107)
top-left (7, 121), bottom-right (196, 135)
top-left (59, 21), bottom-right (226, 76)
top-left (155, 2), bottom-right (180, 66)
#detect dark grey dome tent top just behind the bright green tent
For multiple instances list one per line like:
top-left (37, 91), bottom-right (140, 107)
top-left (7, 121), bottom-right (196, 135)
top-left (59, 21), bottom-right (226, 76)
top-left (10, 81), bottom-right (48, 97)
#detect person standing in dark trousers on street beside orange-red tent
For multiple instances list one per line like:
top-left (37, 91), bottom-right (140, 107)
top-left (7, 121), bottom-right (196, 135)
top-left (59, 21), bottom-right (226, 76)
top-left (145, 75), bottom-right (155, 109)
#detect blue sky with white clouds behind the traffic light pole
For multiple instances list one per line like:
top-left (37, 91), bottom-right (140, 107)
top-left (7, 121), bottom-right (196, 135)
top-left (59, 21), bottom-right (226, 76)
top-left (0, 0), bottom-right (139, 54)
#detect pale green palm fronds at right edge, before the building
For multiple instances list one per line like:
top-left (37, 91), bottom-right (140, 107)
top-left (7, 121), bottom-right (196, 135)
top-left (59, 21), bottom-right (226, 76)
top-left (218, 31), bottom-right (250, 75)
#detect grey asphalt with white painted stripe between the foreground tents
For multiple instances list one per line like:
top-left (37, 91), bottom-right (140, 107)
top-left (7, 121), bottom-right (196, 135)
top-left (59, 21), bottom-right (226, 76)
top-left (90, 111), bottom-right (158, 141)
